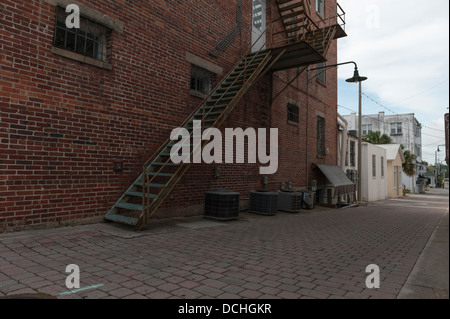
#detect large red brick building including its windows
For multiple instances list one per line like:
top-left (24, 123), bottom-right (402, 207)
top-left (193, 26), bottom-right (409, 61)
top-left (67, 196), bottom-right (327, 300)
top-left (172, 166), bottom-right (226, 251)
top-left (0, 0), bottom-right (345, 232)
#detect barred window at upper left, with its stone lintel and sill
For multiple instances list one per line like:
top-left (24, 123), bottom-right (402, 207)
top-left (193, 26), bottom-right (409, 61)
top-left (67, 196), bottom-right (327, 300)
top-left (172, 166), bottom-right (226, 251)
top-left (53, 6), bottom-right (112, 62)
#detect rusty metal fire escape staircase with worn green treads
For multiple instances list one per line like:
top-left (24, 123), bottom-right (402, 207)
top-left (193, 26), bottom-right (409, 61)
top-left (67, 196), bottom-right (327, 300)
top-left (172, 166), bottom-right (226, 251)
top-left (105, 0), bottom-right (348, 230)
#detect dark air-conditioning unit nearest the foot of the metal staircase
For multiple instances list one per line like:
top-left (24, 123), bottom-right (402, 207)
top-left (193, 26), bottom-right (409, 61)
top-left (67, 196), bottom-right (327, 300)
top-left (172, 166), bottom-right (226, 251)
top-left (204, 189), bottom-right (240, 220)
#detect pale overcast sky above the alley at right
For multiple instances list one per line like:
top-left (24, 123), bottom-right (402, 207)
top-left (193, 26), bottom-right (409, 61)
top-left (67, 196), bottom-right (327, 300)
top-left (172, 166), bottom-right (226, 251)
top-left (338, 0), bottom-right (449, 163)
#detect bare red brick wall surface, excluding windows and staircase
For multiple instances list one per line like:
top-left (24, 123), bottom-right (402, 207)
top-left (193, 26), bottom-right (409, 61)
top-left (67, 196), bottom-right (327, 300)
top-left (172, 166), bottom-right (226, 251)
top-left (0, 0), bottom-right (337, 232)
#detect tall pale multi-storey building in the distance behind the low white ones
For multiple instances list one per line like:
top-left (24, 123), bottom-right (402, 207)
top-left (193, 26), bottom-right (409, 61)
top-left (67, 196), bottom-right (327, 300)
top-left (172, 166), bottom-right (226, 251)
top-left (343, 112), bottom-right (422, 193)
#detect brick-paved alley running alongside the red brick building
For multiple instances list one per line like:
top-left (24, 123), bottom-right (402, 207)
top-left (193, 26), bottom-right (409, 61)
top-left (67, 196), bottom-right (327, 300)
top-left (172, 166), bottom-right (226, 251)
top-left (0, 191), bottom-right (448, 299)
